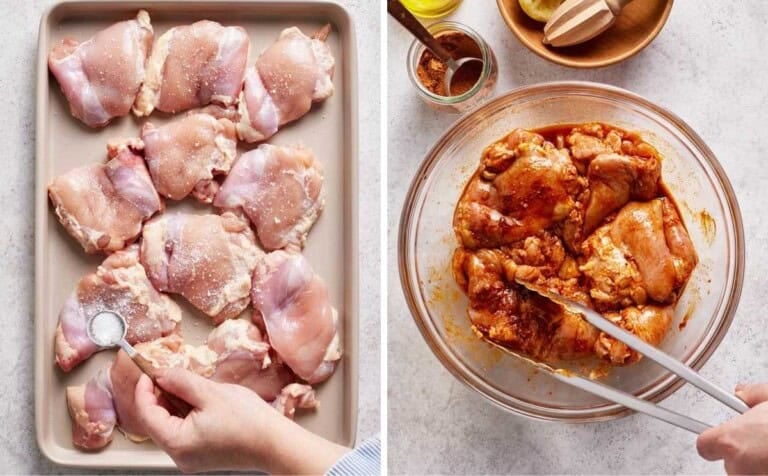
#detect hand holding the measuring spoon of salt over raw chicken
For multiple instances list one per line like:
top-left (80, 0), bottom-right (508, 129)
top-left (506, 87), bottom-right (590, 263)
top-left (135, 369), bottom-right (348, 474)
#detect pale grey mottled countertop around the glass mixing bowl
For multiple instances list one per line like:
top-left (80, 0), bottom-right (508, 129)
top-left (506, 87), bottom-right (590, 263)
top-left (387, 0), bottom-right (768, 474)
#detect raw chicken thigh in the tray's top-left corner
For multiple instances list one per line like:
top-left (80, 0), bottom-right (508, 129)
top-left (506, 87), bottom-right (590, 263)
top-left (48, 10), bottom-right (153, 127)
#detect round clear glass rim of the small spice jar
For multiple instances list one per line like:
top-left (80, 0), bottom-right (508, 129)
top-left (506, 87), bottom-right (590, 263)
top-left (406, 21), bottom-right (496, 106)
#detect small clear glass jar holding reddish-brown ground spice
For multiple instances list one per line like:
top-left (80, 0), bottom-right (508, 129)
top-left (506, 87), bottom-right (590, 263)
top-left (407, 21), bottom-right (498, 112)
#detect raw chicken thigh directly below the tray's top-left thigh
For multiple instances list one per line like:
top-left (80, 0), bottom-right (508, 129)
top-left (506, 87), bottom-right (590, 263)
top-left (48, 142), bottom-right (163, 253)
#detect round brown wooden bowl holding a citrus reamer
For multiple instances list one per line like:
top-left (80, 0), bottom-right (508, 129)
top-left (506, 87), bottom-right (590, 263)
top-left (496, 0), bottom-right (673, 68)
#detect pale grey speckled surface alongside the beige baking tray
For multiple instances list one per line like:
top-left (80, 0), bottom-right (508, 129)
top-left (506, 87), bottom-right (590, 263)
top-left (0, 0), bottom-right (380, 474)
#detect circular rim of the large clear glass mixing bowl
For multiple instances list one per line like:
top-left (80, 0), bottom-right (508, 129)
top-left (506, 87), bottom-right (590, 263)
top-left (398, 81), bottom-right (744, 423)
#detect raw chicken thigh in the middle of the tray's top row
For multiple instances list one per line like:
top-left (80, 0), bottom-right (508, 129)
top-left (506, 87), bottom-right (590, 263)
top-left (133, 20), bottom-right (250, 116)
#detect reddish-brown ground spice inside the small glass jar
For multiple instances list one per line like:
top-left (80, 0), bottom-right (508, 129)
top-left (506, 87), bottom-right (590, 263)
top-left (416, 31), bottom-right (483, 96)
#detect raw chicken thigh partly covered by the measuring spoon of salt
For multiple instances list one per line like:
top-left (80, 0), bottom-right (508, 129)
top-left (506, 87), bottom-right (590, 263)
top-left (55, 245), bottom-right (181, 372)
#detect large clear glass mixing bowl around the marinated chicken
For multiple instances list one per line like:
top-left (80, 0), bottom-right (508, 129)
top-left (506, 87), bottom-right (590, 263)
top-left (398, 82), bottom-right (744, 422)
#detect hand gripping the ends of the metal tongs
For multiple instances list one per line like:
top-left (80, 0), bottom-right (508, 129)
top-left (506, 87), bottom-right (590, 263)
top-left (696, 384), bottom-right (768, 474)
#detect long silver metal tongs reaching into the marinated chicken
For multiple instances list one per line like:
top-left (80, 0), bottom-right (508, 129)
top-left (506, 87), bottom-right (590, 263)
top-left (486, 284), bottom-right (749, 434)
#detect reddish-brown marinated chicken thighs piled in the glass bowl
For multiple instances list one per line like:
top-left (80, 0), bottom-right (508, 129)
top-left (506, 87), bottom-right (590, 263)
top-left (452, 123), bottom-right (697, 365)
